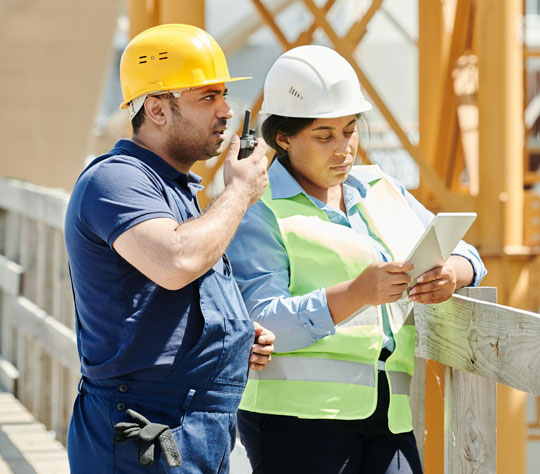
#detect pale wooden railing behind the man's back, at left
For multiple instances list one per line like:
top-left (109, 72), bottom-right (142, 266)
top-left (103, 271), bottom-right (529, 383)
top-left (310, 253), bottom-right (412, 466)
top-left (0, 178), bottom-right (79, 442)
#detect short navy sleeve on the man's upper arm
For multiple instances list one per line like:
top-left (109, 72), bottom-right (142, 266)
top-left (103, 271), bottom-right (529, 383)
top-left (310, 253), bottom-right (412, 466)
top-left (81, 158), bottom-right (176, 247)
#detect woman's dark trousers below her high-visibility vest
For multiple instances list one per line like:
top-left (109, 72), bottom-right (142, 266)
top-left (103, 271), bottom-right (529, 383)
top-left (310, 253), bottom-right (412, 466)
top-left (238, 372), bottom-right (422, 474)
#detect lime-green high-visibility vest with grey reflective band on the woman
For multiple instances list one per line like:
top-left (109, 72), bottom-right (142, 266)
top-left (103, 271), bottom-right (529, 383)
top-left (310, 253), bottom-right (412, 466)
top-left (240, 166), bottom-right (424, 433)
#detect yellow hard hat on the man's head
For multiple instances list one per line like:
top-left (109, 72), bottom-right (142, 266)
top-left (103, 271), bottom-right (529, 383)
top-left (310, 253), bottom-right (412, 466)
top-left (120, 24), bottom-right (251, 115)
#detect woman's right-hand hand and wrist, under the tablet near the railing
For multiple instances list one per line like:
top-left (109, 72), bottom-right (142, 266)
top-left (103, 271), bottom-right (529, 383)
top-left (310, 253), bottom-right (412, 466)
top-left (409, 255), bottom-right (474, 304)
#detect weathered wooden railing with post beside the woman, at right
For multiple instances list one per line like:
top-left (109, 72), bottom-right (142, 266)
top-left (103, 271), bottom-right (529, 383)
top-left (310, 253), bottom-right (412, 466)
top-left (413, 288), bottom-right (540, 474)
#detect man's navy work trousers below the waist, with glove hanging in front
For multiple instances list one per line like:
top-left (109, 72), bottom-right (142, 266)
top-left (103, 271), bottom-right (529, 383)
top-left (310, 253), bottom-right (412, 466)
top-left (68, 379), bottom-right (238, 474)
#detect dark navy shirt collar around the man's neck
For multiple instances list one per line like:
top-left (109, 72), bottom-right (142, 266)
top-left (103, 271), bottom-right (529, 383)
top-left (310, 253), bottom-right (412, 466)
top-left (111, 140), bottom-right (204, 189)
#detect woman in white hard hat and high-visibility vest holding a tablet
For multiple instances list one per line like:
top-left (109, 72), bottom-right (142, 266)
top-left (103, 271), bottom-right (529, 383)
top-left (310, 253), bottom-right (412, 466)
top-left (228, 46), bottom-right (486, 474)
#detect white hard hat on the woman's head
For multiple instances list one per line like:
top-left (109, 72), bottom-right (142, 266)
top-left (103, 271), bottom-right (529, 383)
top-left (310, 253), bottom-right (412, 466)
top-left (261, 45), bottom-right (371, 118)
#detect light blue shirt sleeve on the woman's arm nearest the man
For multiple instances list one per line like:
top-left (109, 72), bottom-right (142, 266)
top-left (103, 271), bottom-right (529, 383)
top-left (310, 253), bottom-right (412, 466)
top-left (227, 201), bottom-right (335, 352)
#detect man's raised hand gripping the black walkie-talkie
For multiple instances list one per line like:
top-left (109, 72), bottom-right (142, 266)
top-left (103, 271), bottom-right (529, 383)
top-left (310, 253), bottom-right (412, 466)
top-left (223, 135), bottom-right (268, 207)
